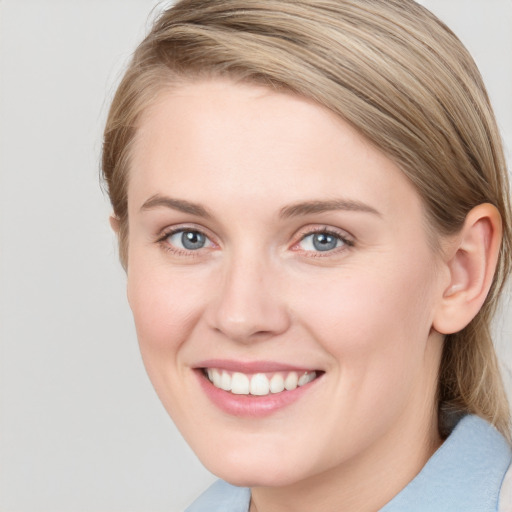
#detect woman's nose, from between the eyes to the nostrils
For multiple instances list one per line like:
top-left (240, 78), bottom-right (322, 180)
top-left (208, 253), bottom-right (290, 343)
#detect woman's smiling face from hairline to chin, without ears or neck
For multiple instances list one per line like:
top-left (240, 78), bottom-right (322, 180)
top-left (128, 80), bottom-right (443, 486)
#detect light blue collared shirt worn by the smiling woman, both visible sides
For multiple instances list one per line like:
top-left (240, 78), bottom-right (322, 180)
top-left (185, 416), bottom-right (512, 512)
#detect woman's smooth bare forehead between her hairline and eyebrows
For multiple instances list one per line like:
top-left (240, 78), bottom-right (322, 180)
top-left (128, 80), bottom-right (419, 220)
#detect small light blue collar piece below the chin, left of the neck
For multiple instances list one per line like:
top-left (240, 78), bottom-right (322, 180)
top-left (185, 480), bottom-right (251, 512)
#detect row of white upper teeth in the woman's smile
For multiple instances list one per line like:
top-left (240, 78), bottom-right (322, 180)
top-left (206, 368), bottom-right (316, 396)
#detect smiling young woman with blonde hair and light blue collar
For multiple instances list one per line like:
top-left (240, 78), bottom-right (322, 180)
top-left (103, 0), bottom-right (512, 512)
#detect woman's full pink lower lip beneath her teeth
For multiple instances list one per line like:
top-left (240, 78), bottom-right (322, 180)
top-left (195, 364), bottom-right (321, 418)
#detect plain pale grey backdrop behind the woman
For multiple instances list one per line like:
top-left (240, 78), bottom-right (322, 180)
top-left (0, 0), bottom-right (512, 512)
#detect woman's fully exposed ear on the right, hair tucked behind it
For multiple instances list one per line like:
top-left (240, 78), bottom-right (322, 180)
top-left (433, 203), bottom-right (502, 334)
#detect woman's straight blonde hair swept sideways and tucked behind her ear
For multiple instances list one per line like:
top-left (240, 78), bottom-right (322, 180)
top-left (103, 0), bottom-right (512, 439)
